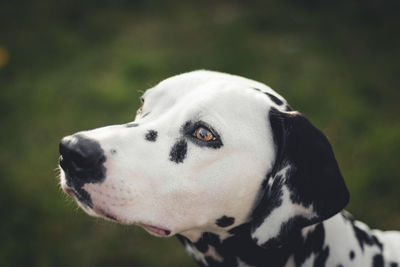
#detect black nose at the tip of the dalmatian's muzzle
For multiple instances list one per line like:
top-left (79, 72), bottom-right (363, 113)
top-left (60, 134), bottom-right (106, 185)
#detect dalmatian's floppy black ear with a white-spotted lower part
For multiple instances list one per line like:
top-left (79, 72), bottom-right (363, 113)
top-left (250, 108), bottom-right (349, 248)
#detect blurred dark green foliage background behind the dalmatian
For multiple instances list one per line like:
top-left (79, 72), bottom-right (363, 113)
top-left (0, 0), bottom-right (400, 266)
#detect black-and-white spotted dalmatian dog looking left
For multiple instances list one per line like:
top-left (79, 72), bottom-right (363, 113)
top-left (59, 70), bottom-right (400, 267)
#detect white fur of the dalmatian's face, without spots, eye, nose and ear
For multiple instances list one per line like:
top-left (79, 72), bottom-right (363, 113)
top-left (58, 71), bottom-right (284, 240)
